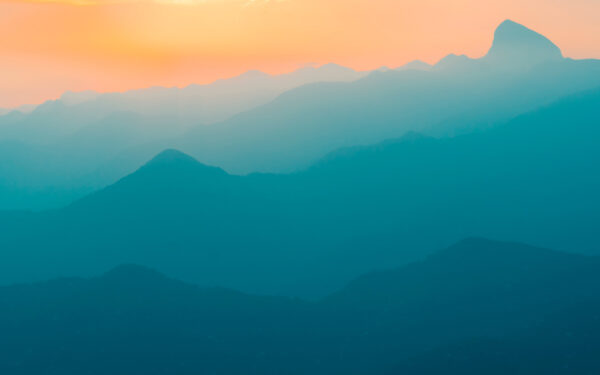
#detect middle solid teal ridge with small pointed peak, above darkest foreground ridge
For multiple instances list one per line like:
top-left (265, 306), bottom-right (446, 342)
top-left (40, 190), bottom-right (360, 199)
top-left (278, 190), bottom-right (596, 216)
top-left (0, 86), bottom-right (600, 297)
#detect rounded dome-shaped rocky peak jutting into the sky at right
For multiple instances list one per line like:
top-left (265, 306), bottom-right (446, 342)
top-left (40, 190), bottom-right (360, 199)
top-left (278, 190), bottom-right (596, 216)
top-left (484, 20), bottom-right (563, 68)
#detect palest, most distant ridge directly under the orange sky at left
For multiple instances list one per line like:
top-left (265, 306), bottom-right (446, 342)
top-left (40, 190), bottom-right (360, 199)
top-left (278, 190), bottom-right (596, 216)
top-left (0, 64), bottom-right (366, 143)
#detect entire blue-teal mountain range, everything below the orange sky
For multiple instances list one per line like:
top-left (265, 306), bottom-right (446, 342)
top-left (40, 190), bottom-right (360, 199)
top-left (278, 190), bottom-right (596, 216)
top-left (0, 16), bottom-right (600, 375)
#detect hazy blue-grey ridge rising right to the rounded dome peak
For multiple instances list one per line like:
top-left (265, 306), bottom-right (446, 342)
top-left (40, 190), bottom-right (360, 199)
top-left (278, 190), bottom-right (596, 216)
top-left (169, 21), bottom-right (600, 173)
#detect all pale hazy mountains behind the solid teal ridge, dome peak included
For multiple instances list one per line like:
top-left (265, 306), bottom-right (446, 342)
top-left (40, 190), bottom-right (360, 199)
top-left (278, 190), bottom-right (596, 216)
top-left (0, 21), bottom-right (600, 209)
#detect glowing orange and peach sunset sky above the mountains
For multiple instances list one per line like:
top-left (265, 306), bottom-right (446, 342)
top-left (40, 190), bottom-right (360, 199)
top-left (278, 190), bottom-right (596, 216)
top-left (0, 0), bottom-right (600, 107)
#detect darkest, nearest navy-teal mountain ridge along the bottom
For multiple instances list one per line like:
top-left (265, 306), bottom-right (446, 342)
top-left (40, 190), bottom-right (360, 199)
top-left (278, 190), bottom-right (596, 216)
top-left (0, 238), bottom-right (600, 375)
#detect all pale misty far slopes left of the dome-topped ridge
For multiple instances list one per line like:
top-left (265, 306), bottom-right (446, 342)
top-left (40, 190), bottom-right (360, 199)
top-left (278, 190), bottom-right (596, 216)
top-left (0, 64), bottom-right (366, 209)
